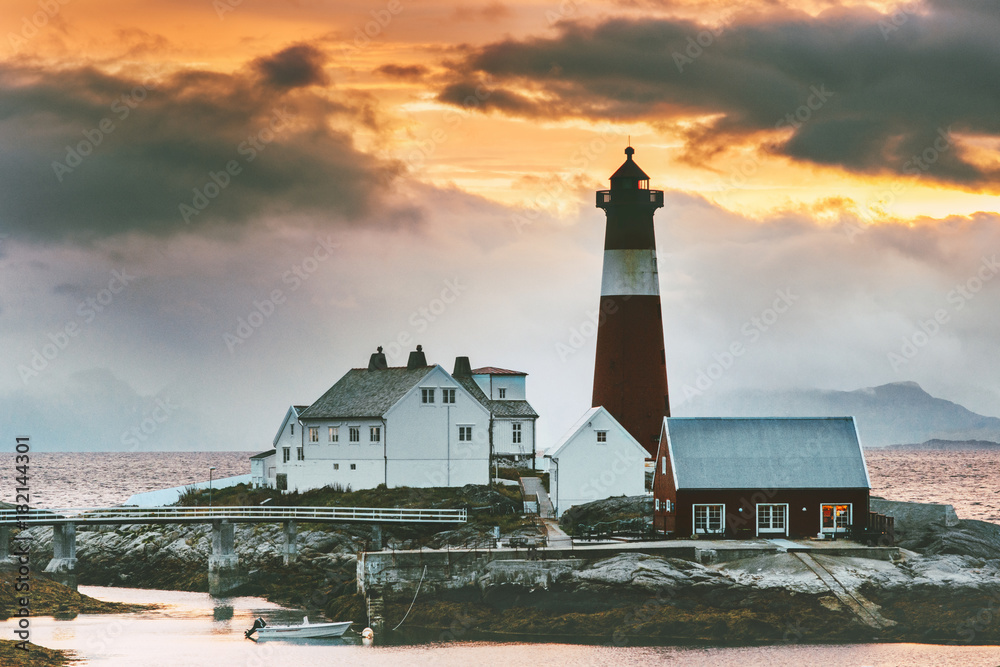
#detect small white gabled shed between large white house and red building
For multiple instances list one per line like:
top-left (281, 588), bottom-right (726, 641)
top-left (545, 407), bottom-right (649, 515)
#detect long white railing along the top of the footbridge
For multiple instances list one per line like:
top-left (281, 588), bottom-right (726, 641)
top-left (0, 506), bottom-right (468, 525)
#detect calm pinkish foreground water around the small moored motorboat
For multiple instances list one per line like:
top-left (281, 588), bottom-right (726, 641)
top-left (21, 586), bottom-right (1000, 667)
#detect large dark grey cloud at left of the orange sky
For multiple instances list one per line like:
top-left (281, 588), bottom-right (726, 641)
top-left (0, 47), bottom-right (406, 241)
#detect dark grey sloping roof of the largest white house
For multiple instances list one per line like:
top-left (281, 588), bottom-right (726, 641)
top-left (299, 366), bottom-right (434, 419)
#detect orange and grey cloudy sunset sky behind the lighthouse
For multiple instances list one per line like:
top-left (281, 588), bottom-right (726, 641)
top-left (0, 0), bottom-right (1000, 451)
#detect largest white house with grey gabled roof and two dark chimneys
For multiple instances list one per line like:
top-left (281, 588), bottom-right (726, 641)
top-left (264, 345), bottom-right (490, 491)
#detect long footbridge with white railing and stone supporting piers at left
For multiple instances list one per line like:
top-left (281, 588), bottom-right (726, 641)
top-left (0, 505), bottom-right (468, 595)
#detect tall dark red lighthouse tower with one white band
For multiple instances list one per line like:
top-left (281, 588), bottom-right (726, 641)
top-left (593, 146), bottom-right (670, 457)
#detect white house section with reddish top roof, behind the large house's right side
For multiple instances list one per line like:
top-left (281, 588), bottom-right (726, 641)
top-left (452, 357), bottom-right (538, 465)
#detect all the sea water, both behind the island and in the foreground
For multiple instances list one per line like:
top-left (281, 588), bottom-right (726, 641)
top-left (0, 449), bottom-right (1000, 667)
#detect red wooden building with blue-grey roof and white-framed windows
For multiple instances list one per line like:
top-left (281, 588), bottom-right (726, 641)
top-left (653, 417), bottom-right (871, 538)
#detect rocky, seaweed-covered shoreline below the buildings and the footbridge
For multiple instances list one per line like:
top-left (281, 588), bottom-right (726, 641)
top-left (13, 490), bottom-right (1000, 645)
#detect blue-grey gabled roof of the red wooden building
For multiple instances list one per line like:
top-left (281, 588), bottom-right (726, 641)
top-left (663, 417), bottom-right (871, 489)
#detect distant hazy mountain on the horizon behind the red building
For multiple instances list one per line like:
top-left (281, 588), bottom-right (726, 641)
top-left (684, 382), bottom-right (1000, 447)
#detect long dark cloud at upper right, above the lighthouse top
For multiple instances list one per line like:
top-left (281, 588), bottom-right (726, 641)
top-left (439, 0), bottom-right (1000, 187)
